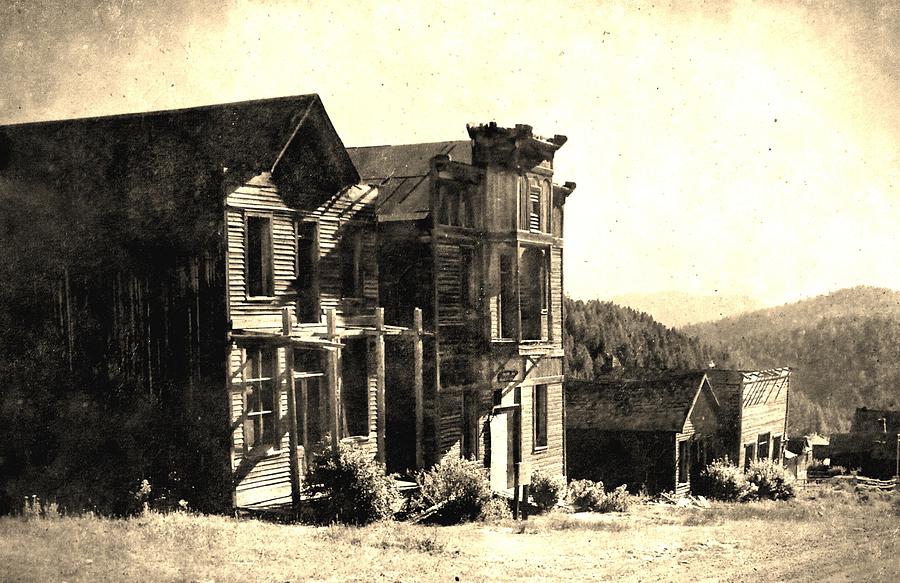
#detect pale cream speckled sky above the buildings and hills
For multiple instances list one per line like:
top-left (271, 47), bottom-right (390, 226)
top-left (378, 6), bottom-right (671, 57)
top-left (0, 0), bottom-right (900, 305)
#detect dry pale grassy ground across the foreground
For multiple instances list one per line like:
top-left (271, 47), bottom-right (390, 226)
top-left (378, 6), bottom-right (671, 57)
top-left (0, 486), bottom-right (900, 582)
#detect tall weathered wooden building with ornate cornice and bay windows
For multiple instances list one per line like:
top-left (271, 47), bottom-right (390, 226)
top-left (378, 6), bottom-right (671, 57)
top-left (350, 124), bottom-right (575, 490)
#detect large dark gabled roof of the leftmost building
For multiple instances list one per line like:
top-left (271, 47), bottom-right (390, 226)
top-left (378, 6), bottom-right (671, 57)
top-left (0, 94), bottom-right (359, 193)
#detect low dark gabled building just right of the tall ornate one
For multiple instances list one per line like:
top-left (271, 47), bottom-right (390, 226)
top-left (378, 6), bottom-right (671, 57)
top-left (566, 372), bottom-right (722, 494)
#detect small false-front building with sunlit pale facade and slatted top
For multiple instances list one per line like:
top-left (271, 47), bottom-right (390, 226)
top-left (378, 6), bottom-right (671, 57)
top-left (706, 367), bottom-right (791, 468)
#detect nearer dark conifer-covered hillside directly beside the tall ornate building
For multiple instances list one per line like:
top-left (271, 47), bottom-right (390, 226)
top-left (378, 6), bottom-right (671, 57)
top-left (565, 298), bottom-right (729, 380)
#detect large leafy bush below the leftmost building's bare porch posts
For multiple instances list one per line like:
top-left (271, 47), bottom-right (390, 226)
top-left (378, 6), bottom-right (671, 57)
top-left (307, 445), bottom-right (400, 525)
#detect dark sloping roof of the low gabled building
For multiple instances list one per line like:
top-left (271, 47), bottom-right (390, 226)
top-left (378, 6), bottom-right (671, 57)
top-left (566, 371), bottom-right (715, 432)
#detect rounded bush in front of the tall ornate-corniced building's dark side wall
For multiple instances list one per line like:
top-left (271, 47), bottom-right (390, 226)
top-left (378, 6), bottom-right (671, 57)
top-left (416, 455), bottom-right (491, 524)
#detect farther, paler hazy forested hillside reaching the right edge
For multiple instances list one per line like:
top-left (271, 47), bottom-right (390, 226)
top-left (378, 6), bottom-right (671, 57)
top-left (682, 287), bottom-right (900, 433)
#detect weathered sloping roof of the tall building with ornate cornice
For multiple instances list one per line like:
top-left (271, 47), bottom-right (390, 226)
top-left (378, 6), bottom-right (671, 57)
top-left (347, 140), bottom-right (472, 215)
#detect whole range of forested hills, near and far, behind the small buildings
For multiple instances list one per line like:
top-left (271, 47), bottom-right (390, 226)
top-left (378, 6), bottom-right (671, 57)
top-left (565, 287), bottom-right (900, 435)
